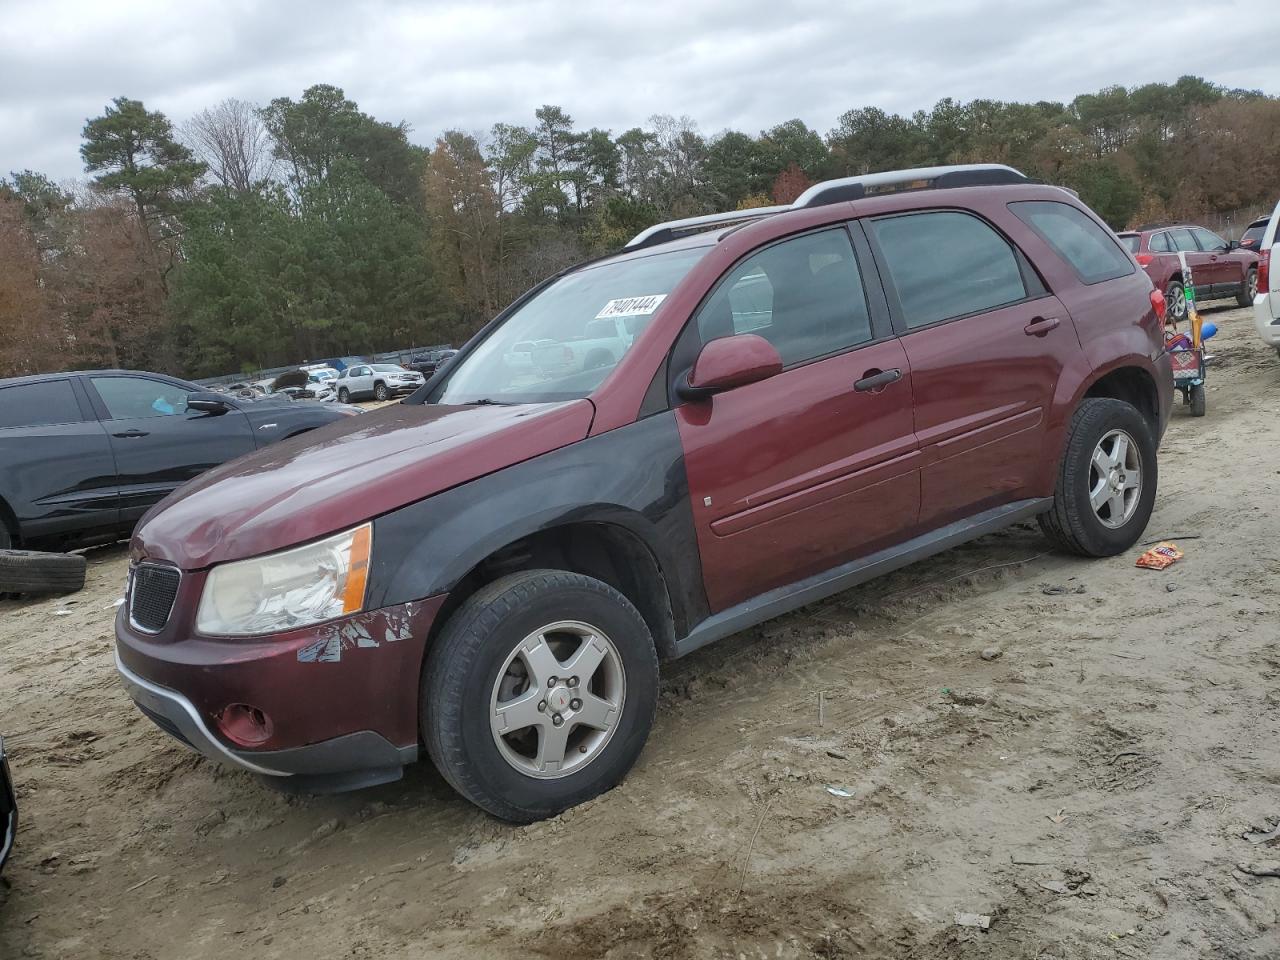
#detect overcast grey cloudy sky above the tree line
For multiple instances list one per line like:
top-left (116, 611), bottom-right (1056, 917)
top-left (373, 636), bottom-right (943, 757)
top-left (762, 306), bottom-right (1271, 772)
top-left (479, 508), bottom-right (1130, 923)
top-left (0, 0), bottom-right (1280, 179)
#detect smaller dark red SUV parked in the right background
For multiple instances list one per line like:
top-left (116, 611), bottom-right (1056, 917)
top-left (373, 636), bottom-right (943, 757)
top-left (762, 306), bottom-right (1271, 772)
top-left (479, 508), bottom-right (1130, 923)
top-left (1120, 224), bottom-right (1258, 323)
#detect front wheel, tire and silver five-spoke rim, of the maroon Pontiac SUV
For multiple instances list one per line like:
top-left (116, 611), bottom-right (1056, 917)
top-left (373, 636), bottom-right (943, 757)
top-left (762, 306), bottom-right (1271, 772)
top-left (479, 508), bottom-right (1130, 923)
top-left (421, 570), bottom-right (658, 823)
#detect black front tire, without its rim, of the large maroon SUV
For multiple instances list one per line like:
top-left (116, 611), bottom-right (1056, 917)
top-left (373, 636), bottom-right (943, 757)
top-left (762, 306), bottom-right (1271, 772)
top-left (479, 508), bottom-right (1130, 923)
top-left (420, 570), bottom-right (658, 823)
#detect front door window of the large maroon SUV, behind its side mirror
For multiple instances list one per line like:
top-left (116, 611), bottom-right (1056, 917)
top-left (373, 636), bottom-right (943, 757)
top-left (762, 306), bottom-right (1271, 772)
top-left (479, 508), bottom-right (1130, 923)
top-left (696, 228), bottom-right (872, 366)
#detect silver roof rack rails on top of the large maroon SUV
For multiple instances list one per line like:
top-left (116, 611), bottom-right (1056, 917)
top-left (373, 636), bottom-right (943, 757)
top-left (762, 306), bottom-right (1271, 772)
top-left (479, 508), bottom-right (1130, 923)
top-left (625, 164), bottom-right (1032, 250)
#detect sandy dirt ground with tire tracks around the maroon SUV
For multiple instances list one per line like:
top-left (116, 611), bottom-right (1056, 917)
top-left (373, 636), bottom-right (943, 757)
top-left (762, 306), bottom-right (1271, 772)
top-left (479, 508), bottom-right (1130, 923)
top-left (0, 308), bottom-right (1280, 960)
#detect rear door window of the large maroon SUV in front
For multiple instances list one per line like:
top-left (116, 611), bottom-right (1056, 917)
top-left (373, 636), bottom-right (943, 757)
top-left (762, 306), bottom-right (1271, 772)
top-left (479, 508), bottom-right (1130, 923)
top-left (870, 210), bottom-right (1027, 329)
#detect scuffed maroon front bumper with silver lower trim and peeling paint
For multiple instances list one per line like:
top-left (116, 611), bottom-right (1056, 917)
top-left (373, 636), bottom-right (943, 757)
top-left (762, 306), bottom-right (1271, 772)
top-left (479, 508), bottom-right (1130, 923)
top-left (115, 593), bottom-right (443, 792)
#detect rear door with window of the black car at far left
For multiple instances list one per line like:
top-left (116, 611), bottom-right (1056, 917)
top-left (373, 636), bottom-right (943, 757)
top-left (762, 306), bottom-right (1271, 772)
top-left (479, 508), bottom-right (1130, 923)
top-left (0, 376), bottom-right (119, 539)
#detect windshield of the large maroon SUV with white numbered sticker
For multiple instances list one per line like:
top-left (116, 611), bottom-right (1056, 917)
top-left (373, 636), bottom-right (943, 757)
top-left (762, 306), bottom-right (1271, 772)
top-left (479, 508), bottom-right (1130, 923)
top-left (435, 247), bottom-right (709, 403)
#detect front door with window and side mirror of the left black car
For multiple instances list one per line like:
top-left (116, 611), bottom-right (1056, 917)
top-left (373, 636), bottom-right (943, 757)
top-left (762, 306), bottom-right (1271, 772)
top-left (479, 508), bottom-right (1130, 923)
top-left (84, 374), bottom-right (255, 524)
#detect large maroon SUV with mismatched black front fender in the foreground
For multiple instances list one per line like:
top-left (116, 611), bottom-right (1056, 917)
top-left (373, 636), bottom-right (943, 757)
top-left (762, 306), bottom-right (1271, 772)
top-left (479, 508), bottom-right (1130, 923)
top-left (116, 165), bottom-right (1172, 820)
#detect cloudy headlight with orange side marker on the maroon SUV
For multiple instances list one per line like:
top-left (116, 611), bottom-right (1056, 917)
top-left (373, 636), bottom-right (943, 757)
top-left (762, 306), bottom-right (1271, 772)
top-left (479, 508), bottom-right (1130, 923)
top-left (196, 524), bottom-right (372, 636)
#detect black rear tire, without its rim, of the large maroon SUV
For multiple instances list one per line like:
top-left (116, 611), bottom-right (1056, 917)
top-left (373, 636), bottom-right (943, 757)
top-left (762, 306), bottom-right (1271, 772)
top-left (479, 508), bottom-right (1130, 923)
top-left (1039, 397), bottom-right (1160, 557)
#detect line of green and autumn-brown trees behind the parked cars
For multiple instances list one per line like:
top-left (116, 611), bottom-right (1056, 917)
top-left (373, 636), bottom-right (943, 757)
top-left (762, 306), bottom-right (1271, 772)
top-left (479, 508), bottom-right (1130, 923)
top-left (0, 77), bottom-right (1280, 376)
